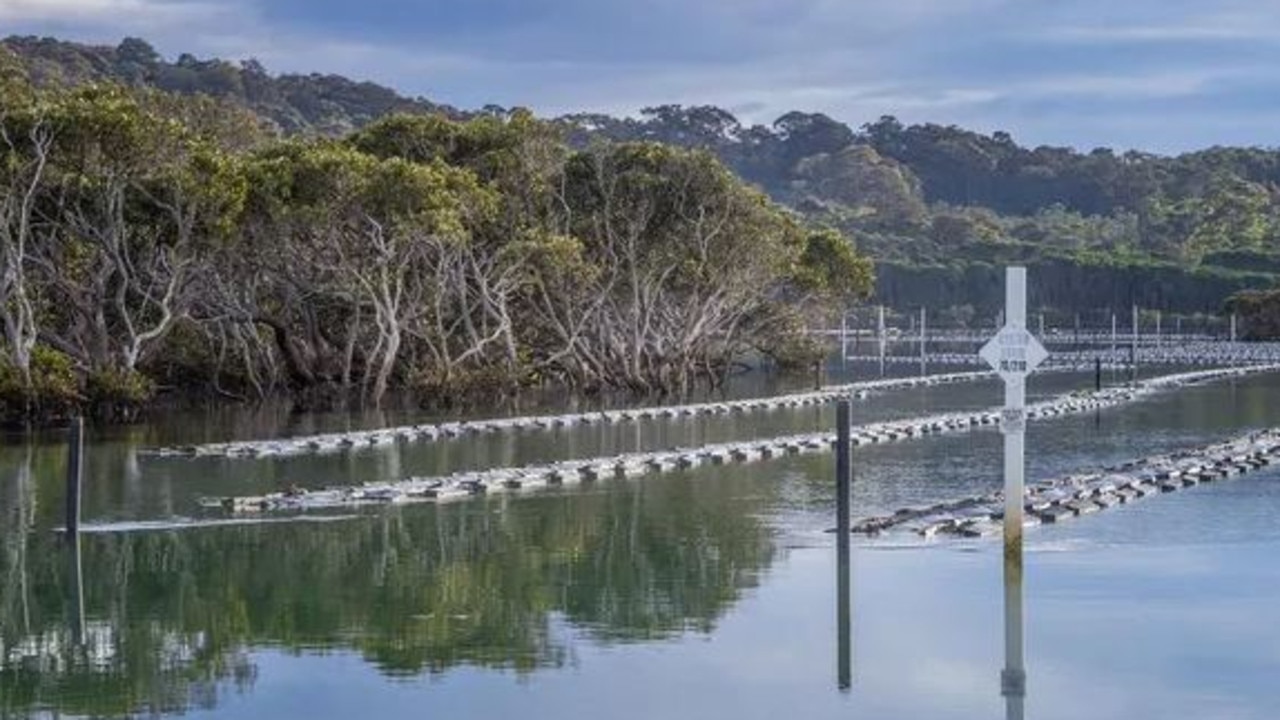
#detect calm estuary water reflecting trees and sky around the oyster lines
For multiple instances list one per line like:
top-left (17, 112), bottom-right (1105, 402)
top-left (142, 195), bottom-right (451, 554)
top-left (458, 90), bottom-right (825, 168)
top-left (0, 366), bottom-right (1280, 719)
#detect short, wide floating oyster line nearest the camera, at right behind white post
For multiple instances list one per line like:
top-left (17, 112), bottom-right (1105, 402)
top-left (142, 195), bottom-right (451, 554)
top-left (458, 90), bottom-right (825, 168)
top-left (850, 428), bottom-right (1280, 539)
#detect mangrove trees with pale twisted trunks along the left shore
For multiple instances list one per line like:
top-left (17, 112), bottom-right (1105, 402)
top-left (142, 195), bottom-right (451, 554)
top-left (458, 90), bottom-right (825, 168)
top-left (0, 50), bottom-right (873, 424)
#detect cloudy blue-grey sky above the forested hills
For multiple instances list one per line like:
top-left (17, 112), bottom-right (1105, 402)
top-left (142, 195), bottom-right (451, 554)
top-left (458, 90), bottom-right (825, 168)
top-left (0, 0), bottom-right (1280, 152)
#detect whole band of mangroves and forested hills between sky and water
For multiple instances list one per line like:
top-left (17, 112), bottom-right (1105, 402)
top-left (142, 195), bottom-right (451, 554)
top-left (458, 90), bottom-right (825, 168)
top-left (0, 37), bottom-right (1280, 424)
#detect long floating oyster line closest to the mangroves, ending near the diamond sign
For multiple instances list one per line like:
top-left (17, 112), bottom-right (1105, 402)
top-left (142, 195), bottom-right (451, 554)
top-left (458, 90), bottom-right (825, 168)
top-left (146, 370), bottom-right (995, 457)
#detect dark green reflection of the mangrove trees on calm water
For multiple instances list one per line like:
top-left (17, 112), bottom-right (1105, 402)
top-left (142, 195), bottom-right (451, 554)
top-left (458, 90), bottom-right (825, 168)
top-left (0, 471), bottom-right (773, 712)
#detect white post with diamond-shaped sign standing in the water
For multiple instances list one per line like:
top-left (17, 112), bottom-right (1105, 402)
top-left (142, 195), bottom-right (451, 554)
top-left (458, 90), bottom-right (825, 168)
top-left (979, 268), bottom-right (1048, 547)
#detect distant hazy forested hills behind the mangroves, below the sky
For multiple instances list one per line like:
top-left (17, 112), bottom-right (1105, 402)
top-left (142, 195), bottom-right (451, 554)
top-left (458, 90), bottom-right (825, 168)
top-left (4, 33), bottom-right (1280, 313)
